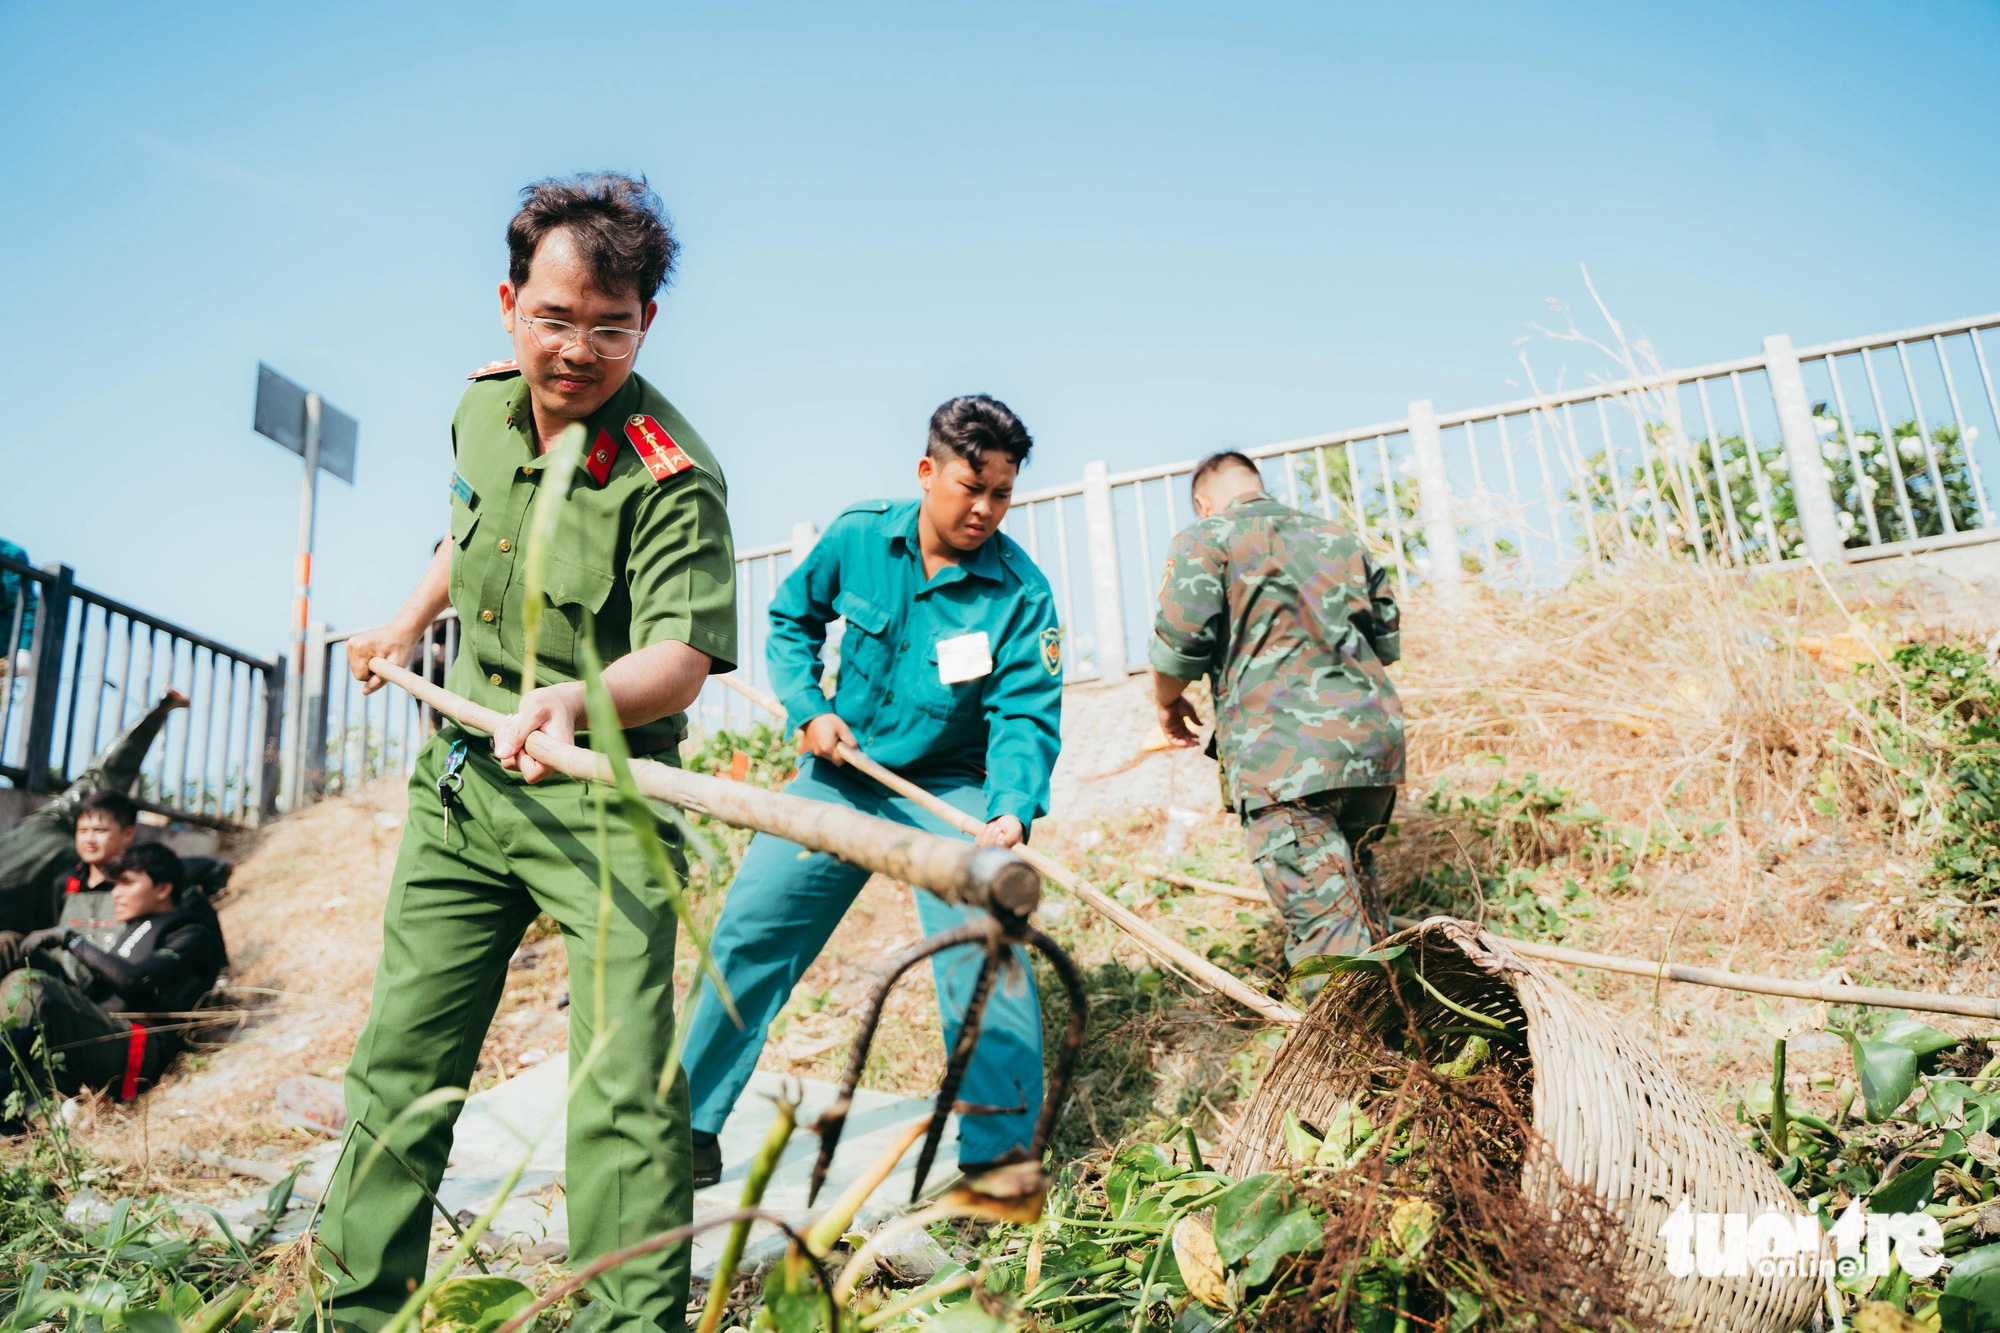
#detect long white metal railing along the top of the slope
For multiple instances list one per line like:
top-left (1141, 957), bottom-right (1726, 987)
top-left (290, 304), bottom-right (2000, 800)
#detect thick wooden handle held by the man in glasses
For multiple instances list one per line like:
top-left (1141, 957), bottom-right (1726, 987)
top-left (368, 656), bottom-right (1042, 917)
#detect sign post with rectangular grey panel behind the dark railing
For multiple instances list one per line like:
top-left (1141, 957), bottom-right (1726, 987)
top-left (252, 362), bottom-right (358, 811)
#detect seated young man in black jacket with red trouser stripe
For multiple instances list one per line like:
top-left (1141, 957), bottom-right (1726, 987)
top-left (0, 843), bottom-right (228, 1131)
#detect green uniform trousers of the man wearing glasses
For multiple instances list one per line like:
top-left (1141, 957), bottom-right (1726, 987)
top-left (302, 725), bottom-right (694, 1333)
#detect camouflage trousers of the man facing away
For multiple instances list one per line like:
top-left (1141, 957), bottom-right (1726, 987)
top-left (1244, 787), bottom-right (1396, 963)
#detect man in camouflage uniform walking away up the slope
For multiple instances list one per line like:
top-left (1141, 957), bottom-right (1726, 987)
top-left (1148, 452), bottom-right (1402, 963)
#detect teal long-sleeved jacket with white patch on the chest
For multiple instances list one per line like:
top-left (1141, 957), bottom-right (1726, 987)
top-left (766, 500), bottom-right (1062, 827)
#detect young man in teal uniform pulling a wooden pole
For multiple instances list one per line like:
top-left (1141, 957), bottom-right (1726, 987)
top-left (682, 394), bottom-right (1062, 1185)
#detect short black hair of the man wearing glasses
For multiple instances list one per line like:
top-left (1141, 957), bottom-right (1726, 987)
top-left (506, 172), bottom-right (680, 304)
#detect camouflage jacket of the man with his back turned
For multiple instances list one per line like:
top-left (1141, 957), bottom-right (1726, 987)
top-left (1148, 494), bottom-right (1402, 813)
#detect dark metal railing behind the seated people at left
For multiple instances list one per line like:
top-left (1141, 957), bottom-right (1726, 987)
top-left (0, 556), bottom-right (284, 825)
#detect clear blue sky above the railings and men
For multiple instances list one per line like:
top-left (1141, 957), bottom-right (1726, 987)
top-left (0, 2), bottom-right (2000, 650)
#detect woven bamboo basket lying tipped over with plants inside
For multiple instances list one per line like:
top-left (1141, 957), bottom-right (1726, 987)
top-left (1228, 917), bottom-right (1824, 1333)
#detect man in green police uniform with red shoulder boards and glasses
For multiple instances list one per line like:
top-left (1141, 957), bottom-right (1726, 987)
top-left (320, 174), bottom-right (736, 1333)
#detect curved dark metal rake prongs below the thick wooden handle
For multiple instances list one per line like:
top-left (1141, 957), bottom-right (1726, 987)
top-left (806, 915), bottom-right (1090, 1207)
